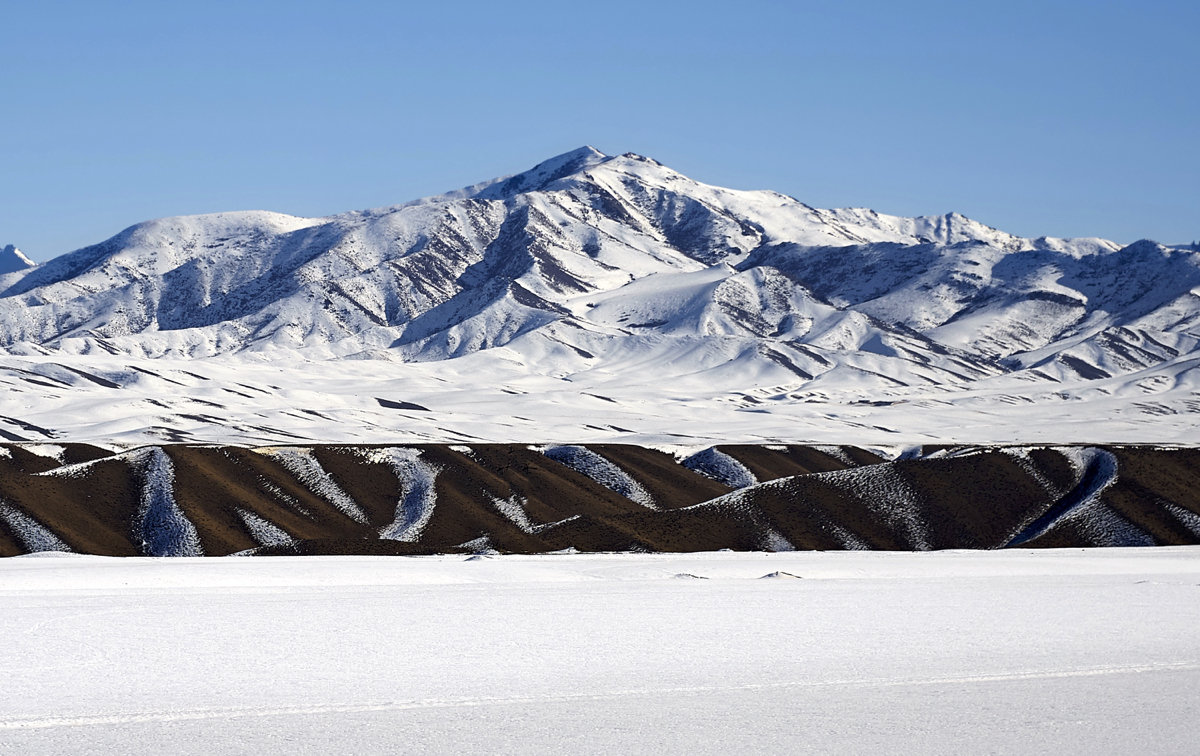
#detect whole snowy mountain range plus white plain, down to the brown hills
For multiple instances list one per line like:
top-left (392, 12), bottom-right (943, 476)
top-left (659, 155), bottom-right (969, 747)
top-left (0, 148), bottom-right (1200, 445)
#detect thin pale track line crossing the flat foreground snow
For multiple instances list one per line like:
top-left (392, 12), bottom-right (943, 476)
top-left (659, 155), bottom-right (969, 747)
top-left (0, 660), bottom-right (1200, 731)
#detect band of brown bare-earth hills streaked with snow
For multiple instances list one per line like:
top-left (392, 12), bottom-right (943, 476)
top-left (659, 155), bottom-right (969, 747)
top-left (0, 444), bottom-right (1200, 557)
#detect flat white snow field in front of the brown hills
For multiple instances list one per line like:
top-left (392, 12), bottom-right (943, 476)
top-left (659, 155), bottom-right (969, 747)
top-left (0, 547), bottom-right (1200, 754)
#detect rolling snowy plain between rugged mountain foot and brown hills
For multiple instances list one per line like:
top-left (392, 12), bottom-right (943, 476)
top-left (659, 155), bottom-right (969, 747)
top-left (0, 347), bottom-right (1200, 450)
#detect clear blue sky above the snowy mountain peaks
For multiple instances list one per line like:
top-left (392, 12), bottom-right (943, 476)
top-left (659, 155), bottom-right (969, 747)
top-left (0, 0), bottom-right (1200, 260)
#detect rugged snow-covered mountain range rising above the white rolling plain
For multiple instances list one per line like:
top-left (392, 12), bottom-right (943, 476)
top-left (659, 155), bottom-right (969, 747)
top-left (0, 148), bottom-right (1200, 440)
